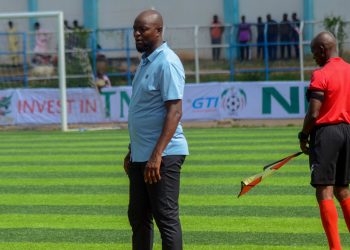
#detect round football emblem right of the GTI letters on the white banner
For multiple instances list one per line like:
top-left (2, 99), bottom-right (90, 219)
top-left (221, 87), bottom-right (247, 115)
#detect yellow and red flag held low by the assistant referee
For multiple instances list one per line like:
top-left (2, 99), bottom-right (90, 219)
top-left (238, 152), bottom-right (302, 198)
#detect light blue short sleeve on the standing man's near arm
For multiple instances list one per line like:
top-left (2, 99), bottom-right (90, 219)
top-left (160, 62), bottom-right (185, 102)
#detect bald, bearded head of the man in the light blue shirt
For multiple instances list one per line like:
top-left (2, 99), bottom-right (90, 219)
top-left (133, 10), bottom-right (163, 55)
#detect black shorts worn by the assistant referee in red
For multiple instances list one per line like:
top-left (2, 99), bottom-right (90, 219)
top-left (309, 123), bottom-right (350, 186)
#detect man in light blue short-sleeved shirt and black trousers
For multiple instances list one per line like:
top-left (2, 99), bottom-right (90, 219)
top-left (124, 10), bottom-right (188, 250)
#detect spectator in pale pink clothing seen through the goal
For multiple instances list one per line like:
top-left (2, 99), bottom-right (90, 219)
top-left (33, 22), bottom-right (51, 64)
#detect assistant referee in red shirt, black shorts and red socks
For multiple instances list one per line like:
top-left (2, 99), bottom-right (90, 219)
top-left (298, 32), bottom-right (350, 250)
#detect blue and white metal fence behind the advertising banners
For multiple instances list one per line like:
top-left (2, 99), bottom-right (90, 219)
top-left (0, 21), bottom-right (350, 87)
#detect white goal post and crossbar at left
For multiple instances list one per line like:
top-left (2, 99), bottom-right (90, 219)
top-left (0, 11), bottom-right (68, 131)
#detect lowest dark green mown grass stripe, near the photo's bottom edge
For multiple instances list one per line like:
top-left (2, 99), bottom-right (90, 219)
top-left (0, 228), bottom-right (350, 246)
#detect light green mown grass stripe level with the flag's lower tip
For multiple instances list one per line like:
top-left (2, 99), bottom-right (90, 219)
top-left (0, 193), bottom-right (316, 207)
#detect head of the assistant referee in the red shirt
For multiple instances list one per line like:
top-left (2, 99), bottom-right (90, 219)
top-left (311, 31), bottom-right (338, 66)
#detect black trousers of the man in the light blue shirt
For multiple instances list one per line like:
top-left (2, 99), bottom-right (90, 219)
top-left (128, 155), bottom-right (185, 250)
